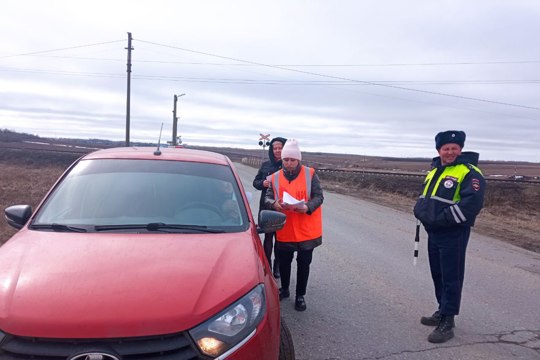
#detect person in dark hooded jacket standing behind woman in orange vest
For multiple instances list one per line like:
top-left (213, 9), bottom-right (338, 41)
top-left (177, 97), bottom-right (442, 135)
top-left (253, 137), bottom-right (287, 278)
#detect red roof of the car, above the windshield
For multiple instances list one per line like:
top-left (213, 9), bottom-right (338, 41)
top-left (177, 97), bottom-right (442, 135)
top-left (82, 146), bottom-right (229, 165)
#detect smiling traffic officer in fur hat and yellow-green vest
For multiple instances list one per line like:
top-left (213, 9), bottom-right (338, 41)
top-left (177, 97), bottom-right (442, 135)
top-left (414, 130), bottom-right (486, 343)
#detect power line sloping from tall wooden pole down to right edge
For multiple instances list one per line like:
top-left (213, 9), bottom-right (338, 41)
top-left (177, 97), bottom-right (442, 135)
top-left (139, 40), bottom-right (540, 111)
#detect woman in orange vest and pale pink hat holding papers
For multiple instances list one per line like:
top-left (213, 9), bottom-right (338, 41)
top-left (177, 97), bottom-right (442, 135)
top-left (265, 139), bottom-right (324, 311)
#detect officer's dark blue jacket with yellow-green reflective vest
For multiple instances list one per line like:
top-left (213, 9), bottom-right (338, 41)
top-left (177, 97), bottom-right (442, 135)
top-left (414, 152), bottom-right (486, 231)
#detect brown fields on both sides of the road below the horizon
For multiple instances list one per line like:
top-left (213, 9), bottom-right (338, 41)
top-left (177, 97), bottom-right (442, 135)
top-left (0, 139), bottom-right (540, 252)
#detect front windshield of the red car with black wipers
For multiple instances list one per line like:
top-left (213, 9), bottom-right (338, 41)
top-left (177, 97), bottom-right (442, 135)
top-left (30, 159), bottom-right (248, 233)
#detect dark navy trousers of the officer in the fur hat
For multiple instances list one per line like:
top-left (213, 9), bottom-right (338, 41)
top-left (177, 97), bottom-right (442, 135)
top-left (427, 227), bottom-right (471, 315)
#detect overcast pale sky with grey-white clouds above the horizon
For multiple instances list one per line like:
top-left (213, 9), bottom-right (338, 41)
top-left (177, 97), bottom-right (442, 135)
top-left (0, 0), bottom-right (540, 162)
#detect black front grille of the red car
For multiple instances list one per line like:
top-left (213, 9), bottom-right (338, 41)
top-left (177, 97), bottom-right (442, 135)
top-left (0, 333), bottom-right (201, 360)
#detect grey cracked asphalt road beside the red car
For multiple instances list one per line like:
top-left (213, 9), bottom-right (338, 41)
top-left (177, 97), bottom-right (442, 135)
top-left (235, 163), bottom-right (540, 360)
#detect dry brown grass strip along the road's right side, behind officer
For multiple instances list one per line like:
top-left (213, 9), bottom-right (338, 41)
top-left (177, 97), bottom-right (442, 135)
top-left (319, 172), bottom-right (540, 252)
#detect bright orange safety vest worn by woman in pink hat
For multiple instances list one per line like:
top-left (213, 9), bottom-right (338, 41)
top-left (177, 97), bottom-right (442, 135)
top-left (272, 166), bottom-right (322, 242)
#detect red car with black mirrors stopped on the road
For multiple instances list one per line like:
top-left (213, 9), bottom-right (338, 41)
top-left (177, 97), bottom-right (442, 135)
top-left (0, 147), bottom-right (294, 360)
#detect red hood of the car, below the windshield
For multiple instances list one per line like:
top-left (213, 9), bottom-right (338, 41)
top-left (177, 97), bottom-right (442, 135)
top-left (0, 229), bottom-right (263, 338)
